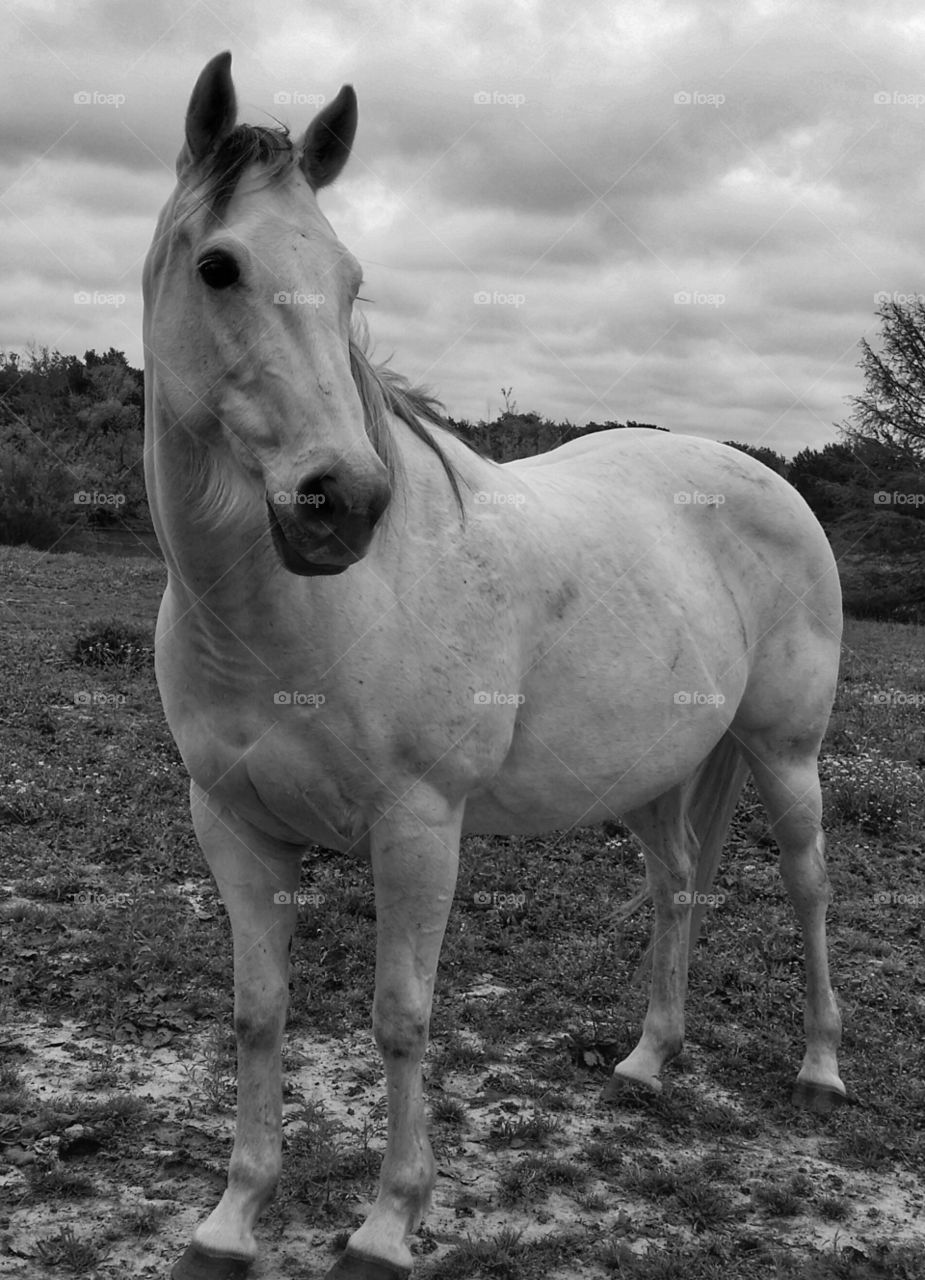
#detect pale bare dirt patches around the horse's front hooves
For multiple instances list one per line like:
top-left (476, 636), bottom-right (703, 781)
top-left (0, 1008), bottom-right (925, 1280)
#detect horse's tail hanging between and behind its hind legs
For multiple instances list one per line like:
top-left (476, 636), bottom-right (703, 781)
top-left (621, 733), bottom-right (748, 983)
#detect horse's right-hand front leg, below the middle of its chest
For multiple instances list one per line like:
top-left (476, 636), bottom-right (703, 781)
top-left (326, 796), bottom-right (462, 1280)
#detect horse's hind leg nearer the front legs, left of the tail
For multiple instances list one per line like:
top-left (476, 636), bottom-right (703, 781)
top-left (604, 787), bottom-right (696, 1100)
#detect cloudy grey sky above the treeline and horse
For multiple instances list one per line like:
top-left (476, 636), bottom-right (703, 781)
top-left (0, 0), bottom-right (925, 456)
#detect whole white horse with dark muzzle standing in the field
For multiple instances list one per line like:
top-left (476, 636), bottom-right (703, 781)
top-left (143, 52), bottom-right (846, 1280)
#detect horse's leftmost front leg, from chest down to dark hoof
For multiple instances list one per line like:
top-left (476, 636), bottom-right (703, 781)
top-left (171, 783), bottom-right (302, 1280)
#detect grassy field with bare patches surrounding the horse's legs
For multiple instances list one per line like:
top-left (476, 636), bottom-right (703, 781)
top-left (0, 548), bottom-right (925, 1280)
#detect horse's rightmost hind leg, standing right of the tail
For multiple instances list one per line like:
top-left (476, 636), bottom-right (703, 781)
top-left (739, 733), bottom-right (846, 1111)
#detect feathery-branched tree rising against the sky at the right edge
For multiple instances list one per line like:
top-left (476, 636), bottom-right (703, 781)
top-left (842, 296), bottom-right (925, 463)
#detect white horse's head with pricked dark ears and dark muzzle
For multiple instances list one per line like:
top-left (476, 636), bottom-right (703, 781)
top-left (145, 54), bottom-right (390, 575)
